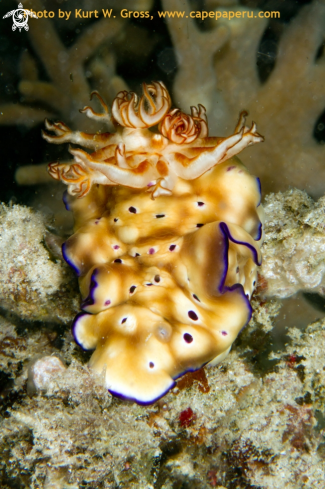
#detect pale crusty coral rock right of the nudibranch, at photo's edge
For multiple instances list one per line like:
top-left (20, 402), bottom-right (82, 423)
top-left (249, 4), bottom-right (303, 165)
top-left (260, 189), bottom-right (325, 298)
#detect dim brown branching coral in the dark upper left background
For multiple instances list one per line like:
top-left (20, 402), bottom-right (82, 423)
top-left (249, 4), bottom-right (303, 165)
top-left (0, 0), bottom-right (152, 135)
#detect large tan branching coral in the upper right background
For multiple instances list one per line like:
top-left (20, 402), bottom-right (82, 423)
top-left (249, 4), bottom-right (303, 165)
top-left (163, 0), bottom-right (325, 196)
